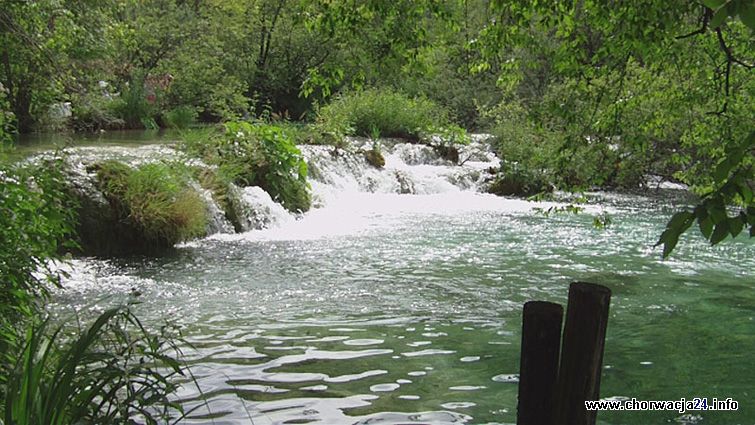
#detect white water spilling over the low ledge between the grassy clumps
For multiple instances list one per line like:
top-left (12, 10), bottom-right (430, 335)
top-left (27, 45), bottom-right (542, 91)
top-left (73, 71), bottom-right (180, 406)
top-left (51, 136), bottom-right (500, 242)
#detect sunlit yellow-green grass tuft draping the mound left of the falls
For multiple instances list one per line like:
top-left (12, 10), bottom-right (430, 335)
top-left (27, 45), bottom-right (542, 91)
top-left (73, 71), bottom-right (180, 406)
top-left (95, 161), bottom-right (207, 249)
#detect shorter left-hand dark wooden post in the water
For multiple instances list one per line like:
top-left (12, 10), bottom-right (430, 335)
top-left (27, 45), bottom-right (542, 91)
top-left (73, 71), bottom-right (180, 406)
top-left (516, 301), bottom-right (564, 425)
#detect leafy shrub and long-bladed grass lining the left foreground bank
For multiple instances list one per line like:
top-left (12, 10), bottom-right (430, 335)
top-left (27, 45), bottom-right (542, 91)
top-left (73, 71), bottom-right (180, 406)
top-left (0, 161), bottom-right (188, 425)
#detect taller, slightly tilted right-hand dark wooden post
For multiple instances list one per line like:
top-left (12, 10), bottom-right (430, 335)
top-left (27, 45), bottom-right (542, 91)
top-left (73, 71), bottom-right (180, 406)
top-left (555, 282), bottom-right (611, 425)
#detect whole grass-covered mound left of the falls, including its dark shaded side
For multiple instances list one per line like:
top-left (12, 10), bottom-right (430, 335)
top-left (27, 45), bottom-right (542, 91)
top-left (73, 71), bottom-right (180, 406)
top-left (76, 161), bottom-right (207, 255)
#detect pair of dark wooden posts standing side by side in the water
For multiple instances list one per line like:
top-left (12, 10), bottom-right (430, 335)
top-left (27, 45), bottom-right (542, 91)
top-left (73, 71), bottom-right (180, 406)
top-left (517, 282), bottom-right (611, 425)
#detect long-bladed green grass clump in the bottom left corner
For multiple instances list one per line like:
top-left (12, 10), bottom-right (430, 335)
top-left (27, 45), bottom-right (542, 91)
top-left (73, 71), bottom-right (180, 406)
top-left (0, 307), bottom-right (184, 425)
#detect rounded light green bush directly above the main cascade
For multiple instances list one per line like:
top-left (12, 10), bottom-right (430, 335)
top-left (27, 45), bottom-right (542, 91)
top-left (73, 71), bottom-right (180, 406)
top-left (317, 89), bottom-right (466, 142)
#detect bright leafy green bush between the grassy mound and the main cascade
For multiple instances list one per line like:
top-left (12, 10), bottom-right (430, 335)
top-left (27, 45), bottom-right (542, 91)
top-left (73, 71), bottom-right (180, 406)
top-left (216, 121), bottom-right (311, 211)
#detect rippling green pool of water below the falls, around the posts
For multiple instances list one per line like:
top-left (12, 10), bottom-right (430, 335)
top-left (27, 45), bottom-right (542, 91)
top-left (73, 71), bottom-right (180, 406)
top-left (50, 192), bottom-right (755, 425)
